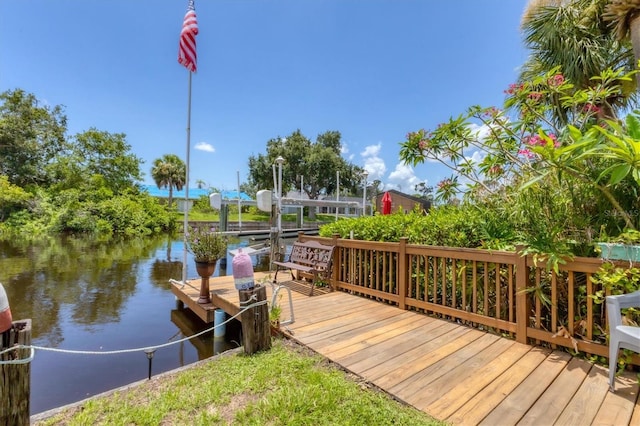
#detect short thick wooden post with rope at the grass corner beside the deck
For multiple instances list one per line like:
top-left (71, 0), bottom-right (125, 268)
top-left (238, 285), bottom-right (271, 355)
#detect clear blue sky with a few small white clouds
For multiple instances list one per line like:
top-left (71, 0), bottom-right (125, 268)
top-left (0, 0), bottom-right (528, 193)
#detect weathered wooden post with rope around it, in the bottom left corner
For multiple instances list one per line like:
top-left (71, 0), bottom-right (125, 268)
top-left (0, 319), bottom-right (31, 426)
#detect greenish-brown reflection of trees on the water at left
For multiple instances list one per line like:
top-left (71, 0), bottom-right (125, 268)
top-left (0, 237), bottom-right (168, 345)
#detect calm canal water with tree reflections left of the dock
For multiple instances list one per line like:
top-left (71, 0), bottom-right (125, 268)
top-left (0, 237), bottom-right (269, 414)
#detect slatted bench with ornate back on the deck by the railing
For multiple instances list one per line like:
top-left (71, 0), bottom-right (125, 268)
top-left (273, 241), bottom-right (334, 296)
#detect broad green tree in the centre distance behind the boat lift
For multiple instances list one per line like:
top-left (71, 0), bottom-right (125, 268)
top-left (249, 130), bottom-right (362, 200)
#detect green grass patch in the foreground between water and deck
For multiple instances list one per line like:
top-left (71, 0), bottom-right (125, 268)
top-left (35, 339), bottom-right (445, 426)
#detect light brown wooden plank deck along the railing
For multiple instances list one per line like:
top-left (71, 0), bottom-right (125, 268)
top-left (174, 273), bottom-right (640, 426)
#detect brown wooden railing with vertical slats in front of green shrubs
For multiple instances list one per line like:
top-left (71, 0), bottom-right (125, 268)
top-left (298, 234), bottom-right (608, 357)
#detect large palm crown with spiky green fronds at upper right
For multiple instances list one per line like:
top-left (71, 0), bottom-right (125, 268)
top-left (520, 0), bottom-right (640, 122)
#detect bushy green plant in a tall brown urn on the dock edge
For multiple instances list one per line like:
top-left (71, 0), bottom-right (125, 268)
top-left (185, 226), bottom-right (227, 303)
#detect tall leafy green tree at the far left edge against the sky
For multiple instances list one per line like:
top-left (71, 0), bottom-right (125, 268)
top-left (0, 89), bottom-right (67, 187)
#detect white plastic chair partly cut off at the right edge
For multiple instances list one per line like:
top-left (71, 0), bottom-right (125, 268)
top-left (606, 290), bottom-right (640, 392)
